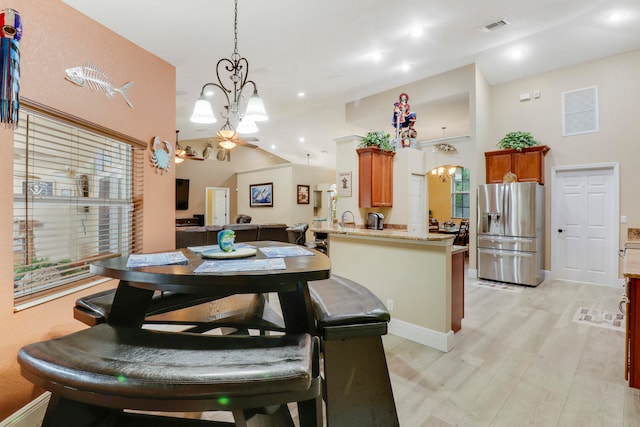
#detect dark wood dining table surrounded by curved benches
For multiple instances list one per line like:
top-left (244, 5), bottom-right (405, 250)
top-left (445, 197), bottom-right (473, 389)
top-left (90, 241), bottom-right (331, 334)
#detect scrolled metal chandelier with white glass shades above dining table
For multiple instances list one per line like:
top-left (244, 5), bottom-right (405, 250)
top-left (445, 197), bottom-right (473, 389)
top-left (191, 0), bottom-right (269, 149)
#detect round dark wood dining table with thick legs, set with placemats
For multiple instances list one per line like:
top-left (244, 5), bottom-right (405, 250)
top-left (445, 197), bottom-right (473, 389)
top-left (90, 241), bottom-right (331, 426)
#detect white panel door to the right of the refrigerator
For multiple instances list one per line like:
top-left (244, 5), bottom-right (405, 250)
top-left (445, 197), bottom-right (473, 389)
top-left (551, 164), bottom-right (619, 285)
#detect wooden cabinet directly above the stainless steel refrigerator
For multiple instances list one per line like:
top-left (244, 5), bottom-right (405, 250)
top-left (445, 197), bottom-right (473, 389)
top-left (484, 145), bottom-right (549, 184)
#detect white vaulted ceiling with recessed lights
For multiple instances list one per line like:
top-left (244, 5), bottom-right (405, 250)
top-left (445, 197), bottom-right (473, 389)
top-left (63, 0), bottom-right (640, 167)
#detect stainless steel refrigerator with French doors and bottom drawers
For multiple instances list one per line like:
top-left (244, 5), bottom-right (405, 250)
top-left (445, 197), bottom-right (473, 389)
top-left (477, 182), bottom-right (544, 286)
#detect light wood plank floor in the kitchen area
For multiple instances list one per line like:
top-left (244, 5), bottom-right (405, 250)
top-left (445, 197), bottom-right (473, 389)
top-left (384, 279), bottom-right (640, 427)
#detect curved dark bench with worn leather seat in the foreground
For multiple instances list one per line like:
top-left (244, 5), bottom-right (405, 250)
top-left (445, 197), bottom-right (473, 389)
top-left (18, 323), bottom-right (322, 427)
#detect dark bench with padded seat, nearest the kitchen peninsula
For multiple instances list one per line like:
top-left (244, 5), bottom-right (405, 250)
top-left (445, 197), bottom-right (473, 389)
top-left (309, 275), bottom-right (399, 427)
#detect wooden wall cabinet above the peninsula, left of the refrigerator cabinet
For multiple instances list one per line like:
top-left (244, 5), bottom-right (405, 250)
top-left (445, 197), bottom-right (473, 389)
top-left (356, 147), bottom-right (396, 208)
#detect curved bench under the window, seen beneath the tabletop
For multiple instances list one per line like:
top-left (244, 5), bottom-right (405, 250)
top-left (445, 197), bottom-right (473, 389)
top-left (73, 289), bottom-right (284, 334)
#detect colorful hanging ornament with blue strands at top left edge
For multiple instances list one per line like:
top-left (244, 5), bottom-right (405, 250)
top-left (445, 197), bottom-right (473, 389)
top-left (0, 9), bottom-right (22, 127)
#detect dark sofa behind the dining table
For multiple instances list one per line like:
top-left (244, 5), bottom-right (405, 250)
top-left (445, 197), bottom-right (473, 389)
top-left (176, 224), bottom-right (298, 248)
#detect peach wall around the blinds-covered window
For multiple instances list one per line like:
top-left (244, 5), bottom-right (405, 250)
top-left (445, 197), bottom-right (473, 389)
top-left (0, 0), bottom-right (175, 420)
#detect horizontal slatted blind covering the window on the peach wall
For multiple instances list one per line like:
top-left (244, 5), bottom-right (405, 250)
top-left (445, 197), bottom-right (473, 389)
top-left (13, 109), bottom-right (134, 298)
